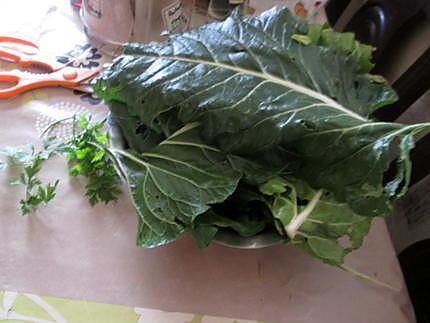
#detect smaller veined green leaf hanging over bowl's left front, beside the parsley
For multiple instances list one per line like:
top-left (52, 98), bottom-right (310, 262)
top-left (113, 124), bottom-right (241, 246)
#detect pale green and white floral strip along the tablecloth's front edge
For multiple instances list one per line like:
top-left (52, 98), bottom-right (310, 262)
top-left (0, 291), bottom-right (264, 323)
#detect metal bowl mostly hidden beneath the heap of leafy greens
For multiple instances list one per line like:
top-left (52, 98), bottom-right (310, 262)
top-left (108, 115), bottom-right (282, 249)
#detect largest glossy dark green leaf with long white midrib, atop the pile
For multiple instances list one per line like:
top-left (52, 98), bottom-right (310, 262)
top-left (97, 8), bottom-right (429, 216)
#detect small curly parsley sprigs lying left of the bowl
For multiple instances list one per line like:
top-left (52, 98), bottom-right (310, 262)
top-left (0, 116), bottom-right (121, 215)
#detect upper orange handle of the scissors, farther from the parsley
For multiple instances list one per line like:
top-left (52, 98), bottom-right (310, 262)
top-left (0, 36), bottom-right (64, 72)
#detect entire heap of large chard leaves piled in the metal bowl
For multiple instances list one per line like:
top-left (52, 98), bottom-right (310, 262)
top-left (91, 8), bottom-right (430, 266)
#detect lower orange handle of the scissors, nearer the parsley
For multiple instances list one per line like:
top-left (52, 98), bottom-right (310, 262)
top-left (0, 67), bottom-right (101, 99)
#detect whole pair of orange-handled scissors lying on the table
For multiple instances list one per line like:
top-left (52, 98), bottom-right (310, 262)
top-left (0, 36), bottom-right (102, 99)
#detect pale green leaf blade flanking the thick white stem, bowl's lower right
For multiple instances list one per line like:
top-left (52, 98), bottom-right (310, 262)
top-left (260, 178), bottom-right (372, 266)
